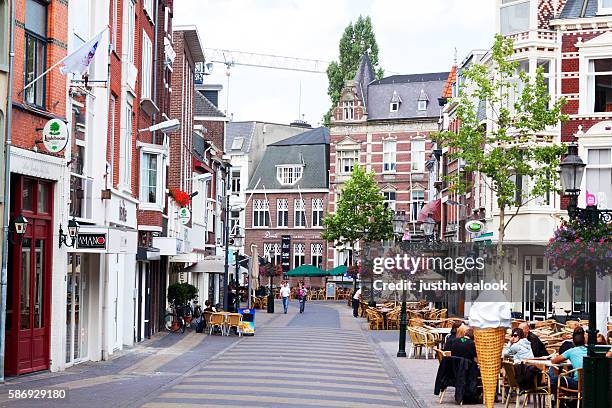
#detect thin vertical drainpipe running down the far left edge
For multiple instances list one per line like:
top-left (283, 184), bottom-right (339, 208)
top-left (0, 1), bottom-right (15, 383)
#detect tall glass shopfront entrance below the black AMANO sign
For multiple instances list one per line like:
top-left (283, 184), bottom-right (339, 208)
top-left (66, 253), bottom-right (89, 364)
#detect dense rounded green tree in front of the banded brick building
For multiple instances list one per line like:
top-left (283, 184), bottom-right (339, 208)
top-left (321, 165), bottom-right (393, 266)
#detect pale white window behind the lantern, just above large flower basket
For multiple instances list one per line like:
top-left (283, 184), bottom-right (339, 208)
top-left (585, 148), bottom-right (612, 208)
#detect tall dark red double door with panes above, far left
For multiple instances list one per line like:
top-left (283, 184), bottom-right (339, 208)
top-left (6, 176), bottom-right (53, 375)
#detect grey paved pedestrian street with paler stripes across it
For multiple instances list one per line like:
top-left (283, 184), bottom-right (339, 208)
top-left (0, 301), bottom-right (418, 408)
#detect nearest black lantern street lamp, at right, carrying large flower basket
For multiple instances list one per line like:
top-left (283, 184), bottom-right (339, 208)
top-left (559, 144), bottom-right (612, 406)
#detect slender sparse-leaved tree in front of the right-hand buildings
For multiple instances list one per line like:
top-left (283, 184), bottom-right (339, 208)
top-left (436, 35), bottom-right (567, 268)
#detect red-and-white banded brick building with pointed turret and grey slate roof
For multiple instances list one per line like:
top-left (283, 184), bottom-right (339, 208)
top-left (327, 54), bottom-right (449, 268)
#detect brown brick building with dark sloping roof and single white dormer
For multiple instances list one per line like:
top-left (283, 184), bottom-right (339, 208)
top-left (245, 127), bottom-right (329, 287)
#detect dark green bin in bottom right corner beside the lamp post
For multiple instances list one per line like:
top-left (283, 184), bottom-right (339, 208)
top-left (583, 346), bottom-right (612, 408)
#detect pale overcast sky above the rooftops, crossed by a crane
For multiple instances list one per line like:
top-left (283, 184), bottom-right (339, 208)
top-left (174, 0), bottom-right (496, 126)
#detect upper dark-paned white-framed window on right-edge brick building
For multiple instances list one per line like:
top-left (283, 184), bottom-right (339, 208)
top-left (587, 58), bottom-right (612, 113)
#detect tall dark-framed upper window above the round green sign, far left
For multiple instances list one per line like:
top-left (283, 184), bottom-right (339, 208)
top-left (24, 0), bottom-right (47, 109)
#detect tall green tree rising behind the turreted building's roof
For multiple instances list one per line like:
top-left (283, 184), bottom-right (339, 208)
top-left (324, 16), bottom-right (383, 125)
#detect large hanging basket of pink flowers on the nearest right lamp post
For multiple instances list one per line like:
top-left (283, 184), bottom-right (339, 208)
top-left (544, 220), bottom-right (612, 276)
